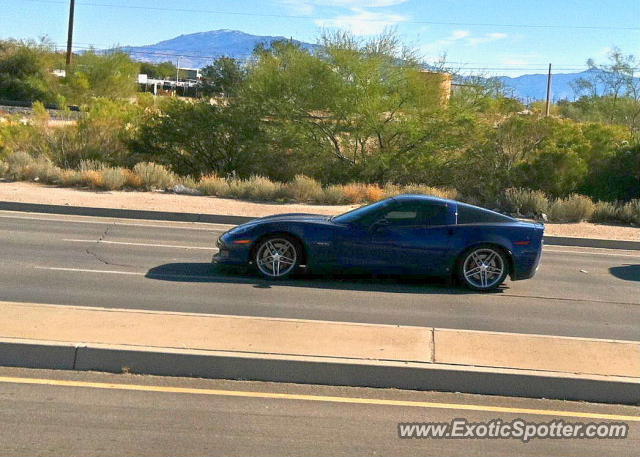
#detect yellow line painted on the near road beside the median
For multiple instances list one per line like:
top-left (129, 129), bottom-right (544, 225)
top-left (0, 376), bottom-right (640, 422)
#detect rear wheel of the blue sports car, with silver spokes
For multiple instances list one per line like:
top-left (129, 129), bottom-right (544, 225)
top-left (458, 246), bottom-right (509, 291)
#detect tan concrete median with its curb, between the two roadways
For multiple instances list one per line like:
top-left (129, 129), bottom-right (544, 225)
top-left (0, 302), bottom-right (640, 404)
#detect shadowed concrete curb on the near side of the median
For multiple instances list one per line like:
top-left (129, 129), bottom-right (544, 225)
top-left (0, 339), bottom-right (640, 405)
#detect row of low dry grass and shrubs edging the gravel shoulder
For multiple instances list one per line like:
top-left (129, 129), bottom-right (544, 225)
top-left (0, 152), bottom-right (640, 225)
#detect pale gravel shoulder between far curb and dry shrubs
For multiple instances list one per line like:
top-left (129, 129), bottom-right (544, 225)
top-left (0, 182), bottom-right (640, 241)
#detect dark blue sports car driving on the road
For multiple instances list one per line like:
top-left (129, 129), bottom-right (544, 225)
top-left (213, 195), bottom-right (544, 291)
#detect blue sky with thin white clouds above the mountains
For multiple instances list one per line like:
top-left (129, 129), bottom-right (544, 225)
top-left (0, 0), bottom-right (640, 76)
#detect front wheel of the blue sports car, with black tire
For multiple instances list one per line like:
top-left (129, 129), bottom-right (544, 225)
top-left (253, 235), bottom-right (302, 279)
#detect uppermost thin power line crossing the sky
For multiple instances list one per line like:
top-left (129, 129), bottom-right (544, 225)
top-left (12, 0), bottom-right (640, 31)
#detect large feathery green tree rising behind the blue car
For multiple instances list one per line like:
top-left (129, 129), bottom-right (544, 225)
top-left (242, 32), bottom-right (444, 181)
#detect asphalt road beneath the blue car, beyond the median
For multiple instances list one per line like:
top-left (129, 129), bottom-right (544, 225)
top-left (0, 211), bottom-right (640, 340)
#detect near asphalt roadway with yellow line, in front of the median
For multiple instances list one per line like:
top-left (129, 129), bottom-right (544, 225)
top-left (0, 368), bottom-right (640, 456)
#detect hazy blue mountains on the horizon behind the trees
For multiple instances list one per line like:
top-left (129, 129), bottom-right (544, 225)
top-left (121, 29), bottom-right (589, 101)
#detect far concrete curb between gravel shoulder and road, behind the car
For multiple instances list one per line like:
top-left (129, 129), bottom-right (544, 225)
top-left (0, 201), bottom-right (640, 250)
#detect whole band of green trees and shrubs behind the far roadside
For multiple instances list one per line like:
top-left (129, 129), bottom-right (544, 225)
top-left (0, 33), bottom-right (640, 223)
